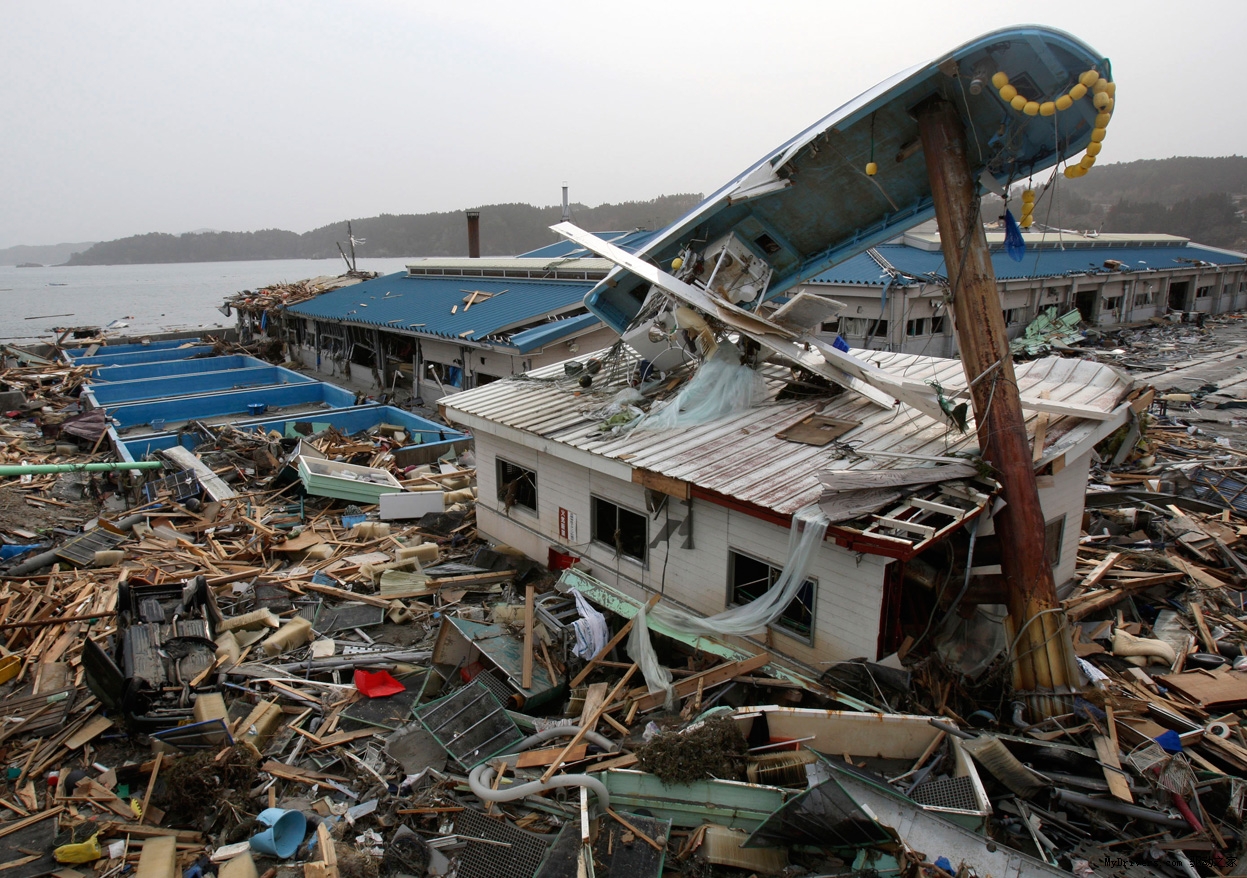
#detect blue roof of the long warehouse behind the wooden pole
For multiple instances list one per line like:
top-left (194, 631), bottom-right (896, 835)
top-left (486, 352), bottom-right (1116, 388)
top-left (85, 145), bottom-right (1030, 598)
top-left (811, 244), bottom-right (1243, 287)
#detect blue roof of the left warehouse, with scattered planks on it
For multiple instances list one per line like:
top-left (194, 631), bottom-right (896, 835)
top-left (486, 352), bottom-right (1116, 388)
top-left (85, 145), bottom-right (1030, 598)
top-left (289, 272), bottom-right (597, 349)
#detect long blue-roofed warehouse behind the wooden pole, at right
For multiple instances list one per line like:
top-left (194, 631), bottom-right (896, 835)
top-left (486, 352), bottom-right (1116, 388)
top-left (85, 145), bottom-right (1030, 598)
top-left (799, 222), bottom-right (1247, 357)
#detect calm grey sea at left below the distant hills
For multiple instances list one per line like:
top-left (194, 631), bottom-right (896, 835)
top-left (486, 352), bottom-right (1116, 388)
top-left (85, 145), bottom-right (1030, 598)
top-left (0, 258), bottom-right (412, 342)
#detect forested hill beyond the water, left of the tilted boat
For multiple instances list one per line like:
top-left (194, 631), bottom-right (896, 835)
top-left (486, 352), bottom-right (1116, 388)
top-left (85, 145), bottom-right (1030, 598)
top-left (60, 193), bottom-right (702, 266)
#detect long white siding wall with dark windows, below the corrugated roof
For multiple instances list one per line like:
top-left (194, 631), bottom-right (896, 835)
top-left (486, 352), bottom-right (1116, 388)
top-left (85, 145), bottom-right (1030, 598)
top-left (476, 433), bottom-right (888, 668)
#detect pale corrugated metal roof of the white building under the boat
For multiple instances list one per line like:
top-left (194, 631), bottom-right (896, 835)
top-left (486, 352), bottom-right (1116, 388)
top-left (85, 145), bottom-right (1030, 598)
top-left (441, 352), bottom-right (1130, 515)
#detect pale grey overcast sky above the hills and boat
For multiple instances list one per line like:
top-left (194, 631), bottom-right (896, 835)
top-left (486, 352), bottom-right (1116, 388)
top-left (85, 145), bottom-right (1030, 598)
top-left (0, 0), bottom-right (1247, 247)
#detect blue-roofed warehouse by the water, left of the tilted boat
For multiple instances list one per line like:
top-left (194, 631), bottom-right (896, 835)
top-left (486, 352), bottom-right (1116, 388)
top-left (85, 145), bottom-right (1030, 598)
top-left (274, 231), bottom-right (652, 404)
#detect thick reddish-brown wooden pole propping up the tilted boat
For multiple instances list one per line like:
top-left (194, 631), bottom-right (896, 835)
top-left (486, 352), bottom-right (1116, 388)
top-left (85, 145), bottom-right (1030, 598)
top-left (918, 99), bottom-right (1079, 722)
